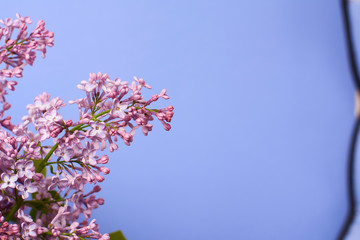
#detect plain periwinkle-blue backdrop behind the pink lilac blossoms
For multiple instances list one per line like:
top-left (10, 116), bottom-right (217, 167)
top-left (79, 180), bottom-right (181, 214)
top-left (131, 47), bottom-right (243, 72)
top-left (0, 0), bottom-right (354, 240)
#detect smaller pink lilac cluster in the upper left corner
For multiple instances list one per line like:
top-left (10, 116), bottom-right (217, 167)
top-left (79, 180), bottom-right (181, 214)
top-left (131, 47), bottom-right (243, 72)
top-left (0, 14), bottom-right (54, 126)
